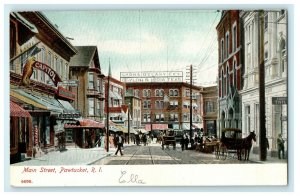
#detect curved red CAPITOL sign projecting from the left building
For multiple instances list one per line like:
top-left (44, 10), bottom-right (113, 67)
top-left (21, 57), bottom-right (61, 86)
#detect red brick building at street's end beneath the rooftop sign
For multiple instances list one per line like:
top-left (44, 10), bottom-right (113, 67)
top-left (126, 82), bottom-right (203, 134)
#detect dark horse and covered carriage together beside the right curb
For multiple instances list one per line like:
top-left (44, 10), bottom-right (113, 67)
top-left (215, 128), bottom-right (256, 160)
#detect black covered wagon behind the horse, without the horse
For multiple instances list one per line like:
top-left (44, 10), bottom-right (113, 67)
top-left (214, 128), bottom-right (242, 160)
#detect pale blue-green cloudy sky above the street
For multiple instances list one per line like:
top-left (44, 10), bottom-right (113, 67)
top-left (43, 9), bottom-right (221, 86)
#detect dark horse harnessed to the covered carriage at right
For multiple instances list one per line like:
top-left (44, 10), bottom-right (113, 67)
top-left (237, 131), bottom-right (256, 161)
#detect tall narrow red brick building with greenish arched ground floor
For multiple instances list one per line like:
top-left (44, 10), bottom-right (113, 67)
top-left (216, 10), bottom-right (243, 136)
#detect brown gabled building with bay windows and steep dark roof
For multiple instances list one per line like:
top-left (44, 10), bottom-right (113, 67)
top-left (70, 46), bottom-right (104, 122)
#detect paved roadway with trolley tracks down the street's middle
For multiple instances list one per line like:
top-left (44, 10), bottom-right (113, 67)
top-left (93, 145), bottom-right (254, 165)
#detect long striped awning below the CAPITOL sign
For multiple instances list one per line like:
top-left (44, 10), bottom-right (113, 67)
top-left (10, 89), bottom-right (63, 114)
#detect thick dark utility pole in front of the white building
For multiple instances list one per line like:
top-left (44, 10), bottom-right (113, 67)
top-left (258, 10), bottom-right (267, 161)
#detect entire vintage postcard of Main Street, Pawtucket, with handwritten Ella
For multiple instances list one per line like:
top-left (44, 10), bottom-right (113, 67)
top-left (7, 7), bottom-right (289, 187)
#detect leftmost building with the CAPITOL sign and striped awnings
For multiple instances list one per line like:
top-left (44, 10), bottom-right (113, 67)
top-left (10, 12), bottom-right (80, 162)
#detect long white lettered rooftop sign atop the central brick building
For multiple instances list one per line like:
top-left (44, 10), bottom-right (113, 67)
top-left (120, 71), bottom-right (183, 83)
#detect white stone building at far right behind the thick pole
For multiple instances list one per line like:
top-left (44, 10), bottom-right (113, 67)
top-left (240, 10), bottom-right (288, 156)
